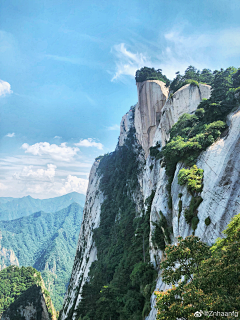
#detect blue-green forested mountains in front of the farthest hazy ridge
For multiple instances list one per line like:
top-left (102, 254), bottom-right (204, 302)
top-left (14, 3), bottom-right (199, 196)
top-left (0, 203), bottom-right (83, 310)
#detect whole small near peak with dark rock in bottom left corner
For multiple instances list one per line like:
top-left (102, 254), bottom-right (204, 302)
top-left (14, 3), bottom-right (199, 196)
top-left (0, 266), bottom-right (56, 320)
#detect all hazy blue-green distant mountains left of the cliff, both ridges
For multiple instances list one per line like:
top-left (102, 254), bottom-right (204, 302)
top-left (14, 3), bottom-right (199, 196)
top-left (0, 192), bottom-right (85, 310)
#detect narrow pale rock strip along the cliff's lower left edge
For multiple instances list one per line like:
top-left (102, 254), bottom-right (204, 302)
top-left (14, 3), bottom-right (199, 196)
top-left (60, 160), bottom-right (104, 320)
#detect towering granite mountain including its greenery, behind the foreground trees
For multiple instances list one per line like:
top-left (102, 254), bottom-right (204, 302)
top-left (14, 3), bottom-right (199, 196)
top-left (59, 68), bottom-right (240, 320)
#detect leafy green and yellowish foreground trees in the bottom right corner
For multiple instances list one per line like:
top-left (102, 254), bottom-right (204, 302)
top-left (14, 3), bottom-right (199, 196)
top-left (156, 214), bottom-right (240, 320)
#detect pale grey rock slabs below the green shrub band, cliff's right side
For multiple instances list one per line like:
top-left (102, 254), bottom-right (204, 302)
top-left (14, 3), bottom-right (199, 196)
top-left (143, 109), bottom-right (240, 320)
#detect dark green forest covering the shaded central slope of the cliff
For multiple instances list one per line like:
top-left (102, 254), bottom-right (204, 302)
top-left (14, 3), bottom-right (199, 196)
top-left (68, 130), bottom-right (157, 320)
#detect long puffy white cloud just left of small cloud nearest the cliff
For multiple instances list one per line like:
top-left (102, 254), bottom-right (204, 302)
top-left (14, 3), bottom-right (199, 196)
top-left (22, 142), bottom-right (79, 161)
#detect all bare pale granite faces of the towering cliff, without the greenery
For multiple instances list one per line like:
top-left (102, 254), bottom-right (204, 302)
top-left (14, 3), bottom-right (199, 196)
top-left (60, 80), bottom-right (240, 320)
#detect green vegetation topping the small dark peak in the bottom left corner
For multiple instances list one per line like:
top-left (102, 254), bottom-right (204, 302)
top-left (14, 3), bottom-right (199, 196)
top-left (0, 266), bottom-right (54, 320)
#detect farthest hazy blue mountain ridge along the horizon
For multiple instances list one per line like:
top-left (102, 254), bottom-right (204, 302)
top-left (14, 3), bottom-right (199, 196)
top-left (0, 192), bottom-right (85, 221)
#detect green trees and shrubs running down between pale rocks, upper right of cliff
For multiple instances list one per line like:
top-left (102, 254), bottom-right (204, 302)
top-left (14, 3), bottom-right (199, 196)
top-left (150, 66), bottom-right (240, 230)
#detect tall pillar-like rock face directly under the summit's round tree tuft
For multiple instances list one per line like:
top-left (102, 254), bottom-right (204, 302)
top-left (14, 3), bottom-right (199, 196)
top-left (134, 80), bottom-right (168, 156)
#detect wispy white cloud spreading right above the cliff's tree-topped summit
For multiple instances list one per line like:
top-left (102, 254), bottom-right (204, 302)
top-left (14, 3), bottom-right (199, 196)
top-left (112, 26), bottom-right (240, 81)
